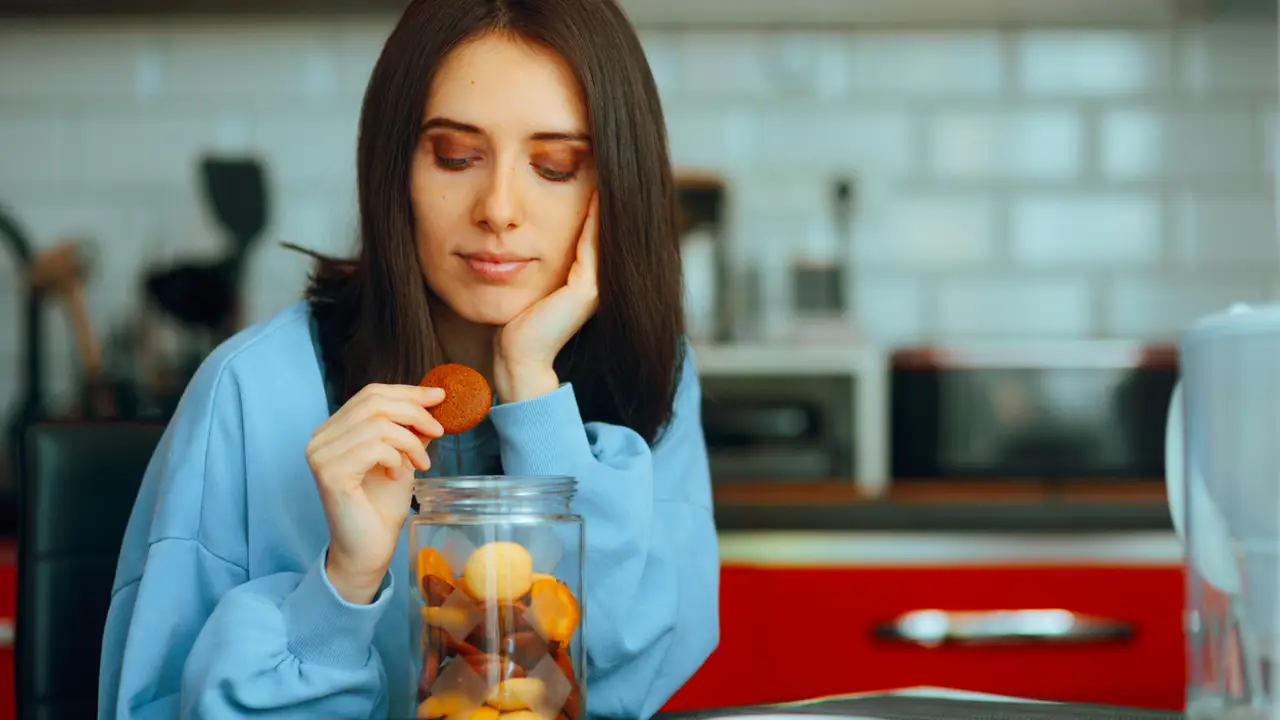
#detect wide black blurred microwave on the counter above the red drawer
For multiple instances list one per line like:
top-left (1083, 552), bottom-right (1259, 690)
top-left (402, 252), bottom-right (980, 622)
top-left (890, 341), bottom-right (1178, 483)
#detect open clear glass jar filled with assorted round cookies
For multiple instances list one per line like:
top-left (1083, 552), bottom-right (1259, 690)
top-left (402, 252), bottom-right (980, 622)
top-left (408, 475), bottom-right (586, 720)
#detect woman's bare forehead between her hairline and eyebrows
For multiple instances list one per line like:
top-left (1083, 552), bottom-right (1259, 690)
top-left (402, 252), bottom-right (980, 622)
top-left (426, 33), bottom-right (586, 135)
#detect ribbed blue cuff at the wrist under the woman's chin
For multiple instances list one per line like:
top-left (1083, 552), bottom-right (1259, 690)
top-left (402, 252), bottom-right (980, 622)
top-left (489, 383), bottom-right (594, 475)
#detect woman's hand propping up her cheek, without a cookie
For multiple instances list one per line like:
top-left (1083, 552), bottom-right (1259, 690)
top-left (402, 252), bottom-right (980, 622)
top-left (493, 192), bottom-right (600, 402)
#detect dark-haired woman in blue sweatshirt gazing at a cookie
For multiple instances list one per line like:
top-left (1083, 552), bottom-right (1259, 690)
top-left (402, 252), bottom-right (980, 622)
top-left (99, 0), bottom-right (718, 717)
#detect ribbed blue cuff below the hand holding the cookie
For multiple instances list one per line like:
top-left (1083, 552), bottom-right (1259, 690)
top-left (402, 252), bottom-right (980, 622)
top-left (280, 546), bottom-right (394, 667)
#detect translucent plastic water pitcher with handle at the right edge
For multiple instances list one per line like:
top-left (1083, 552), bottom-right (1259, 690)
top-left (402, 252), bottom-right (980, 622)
top-left (1166, 299), bottom-right (1280, 720)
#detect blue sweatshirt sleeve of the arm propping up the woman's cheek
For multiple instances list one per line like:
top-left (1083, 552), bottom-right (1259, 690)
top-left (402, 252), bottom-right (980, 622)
top-left (490, 351), bottom-right (719, 717)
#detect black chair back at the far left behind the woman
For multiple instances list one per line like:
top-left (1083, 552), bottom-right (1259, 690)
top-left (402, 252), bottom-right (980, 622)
top-left (14, 423), bottom-right (164, 720)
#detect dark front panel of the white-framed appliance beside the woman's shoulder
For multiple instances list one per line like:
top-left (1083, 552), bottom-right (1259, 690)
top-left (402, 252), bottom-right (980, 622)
top-left (703, 375), bottom-right (854, 483)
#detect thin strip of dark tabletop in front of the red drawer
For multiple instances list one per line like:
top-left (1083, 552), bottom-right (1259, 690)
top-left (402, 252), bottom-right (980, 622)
top-left (654, 693), bottom-right (1185, 720)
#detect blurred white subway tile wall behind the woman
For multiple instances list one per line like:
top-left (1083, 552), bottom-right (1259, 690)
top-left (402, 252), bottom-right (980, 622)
top-left (0, 17), bottom-right (1280, 407)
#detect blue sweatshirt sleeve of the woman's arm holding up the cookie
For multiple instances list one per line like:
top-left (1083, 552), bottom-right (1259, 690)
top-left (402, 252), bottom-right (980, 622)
top-left (99, 345), bottom-right (393, 720)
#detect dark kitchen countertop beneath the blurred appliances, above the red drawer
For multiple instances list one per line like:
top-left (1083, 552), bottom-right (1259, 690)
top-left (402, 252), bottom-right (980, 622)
top-left (714, 480), bottom-right (1172, 533)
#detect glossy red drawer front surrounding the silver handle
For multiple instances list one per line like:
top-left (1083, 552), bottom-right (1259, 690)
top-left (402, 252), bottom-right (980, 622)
top-left (667, 556), bottom-right (1185, 710)
